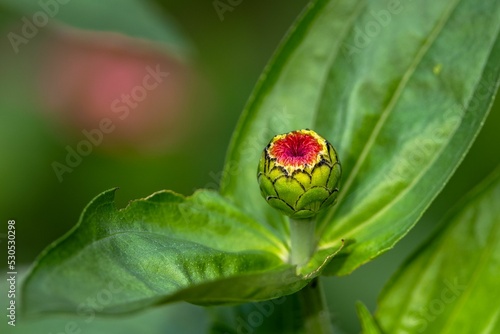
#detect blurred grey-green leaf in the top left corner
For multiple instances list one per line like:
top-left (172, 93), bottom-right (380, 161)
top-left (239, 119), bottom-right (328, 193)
top-left (0, 0), bottom-right (191, 56)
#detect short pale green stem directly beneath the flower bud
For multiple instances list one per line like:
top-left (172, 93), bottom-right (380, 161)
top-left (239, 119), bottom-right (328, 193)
top-left (290, 219), bottom-right (316, 266)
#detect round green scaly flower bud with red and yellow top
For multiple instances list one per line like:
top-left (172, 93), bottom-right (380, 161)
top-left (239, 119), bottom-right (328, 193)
top-left (257, 129), bottom-right (342, 219)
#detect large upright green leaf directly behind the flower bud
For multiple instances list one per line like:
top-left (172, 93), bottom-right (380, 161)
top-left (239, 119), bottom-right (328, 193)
top-left (221, 0), bottom-right (500, 275)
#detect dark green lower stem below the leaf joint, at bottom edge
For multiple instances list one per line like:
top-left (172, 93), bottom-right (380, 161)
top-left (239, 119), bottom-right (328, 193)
top-left (299, 277), bottom-right (333, 334)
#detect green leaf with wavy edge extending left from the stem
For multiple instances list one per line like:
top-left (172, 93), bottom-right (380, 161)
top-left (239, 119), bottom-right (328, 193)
top-left (23, 190), bottom-right (307, 314)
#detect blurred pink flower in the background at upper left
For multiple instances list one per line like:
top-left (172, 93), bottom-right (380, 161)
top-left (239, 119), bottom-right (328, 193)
top-left (40, 27), bottom-right (193, 151)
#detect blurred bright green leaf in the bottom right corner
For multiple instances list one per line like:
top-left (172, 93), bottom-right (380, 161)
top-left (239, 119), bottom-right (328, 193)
top-left (376, 166), bottom-right (500, 334)
